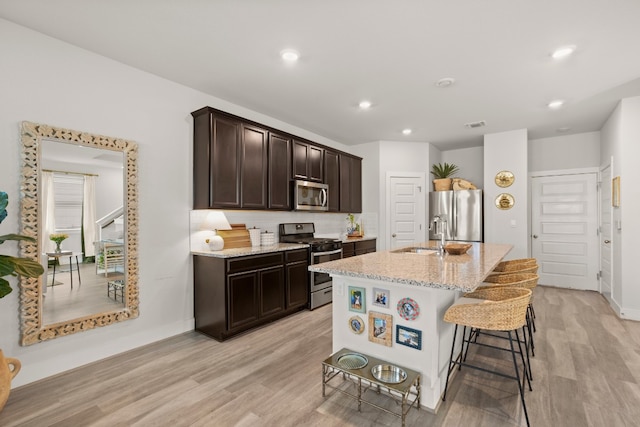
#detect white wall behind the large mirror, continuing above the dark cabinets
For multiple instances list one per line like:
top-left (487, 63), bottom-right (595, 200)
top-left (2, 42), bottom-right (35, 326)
top-left (0, 19), bottom-right (346, 387)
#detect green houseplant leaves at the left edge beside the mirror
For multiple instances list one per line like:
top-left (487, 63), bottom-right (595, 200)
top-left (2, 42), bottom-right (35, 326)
top-left (0, 191), bottom-right (44, 298)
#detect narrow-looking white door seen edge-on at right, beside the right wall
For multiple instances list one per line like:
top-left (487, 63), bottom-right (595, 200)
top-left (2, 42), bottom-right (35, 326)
top-left (600, 165), bottom-right (613, 301)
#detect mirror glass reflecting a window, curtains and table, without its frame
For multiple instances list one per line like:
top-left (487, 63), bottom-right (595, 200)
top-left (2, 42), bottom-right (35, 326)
top-left (40, 140), bottom-right (126, 325)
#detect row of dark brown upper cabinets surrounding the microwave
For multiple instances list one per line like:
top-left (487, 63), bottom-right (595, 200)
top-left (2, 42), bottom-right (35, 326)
top-left (191, 107), bottom-right (362, 213)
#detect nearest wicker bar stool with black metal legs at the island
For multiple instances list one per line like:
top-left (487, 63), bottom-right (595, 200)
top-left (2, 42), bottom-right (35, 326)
top-left (442, 286), bottom-right (531, 426)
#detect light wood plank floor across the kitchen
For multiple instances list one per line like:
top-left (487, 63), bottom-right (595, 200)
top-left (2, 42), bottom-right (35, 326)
top-left (0, 286), bottom-right (640, 427)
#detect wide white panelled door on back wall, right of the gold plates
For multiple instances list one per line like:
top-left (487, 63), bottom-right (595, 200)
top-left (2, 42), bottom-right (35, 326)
top-left (531, 172), bottom-right (599, 291)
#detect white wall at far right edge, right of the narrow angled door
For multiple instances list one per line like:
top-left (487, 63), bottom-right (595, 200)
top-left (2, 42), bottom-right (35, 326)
top-left (601, 97), bottom-right (640, 320)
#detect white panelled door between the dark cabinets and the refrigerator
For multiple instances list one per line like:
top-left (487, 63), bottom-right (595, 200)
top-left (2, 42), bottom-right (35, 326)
top-left (387, 175), bottom-right (425, 249)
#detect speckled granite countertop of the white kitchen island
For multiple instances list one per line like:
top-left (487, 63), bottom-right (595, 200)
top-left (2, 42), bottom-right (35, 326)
top-left (309, 242), bottom-right (513, 292)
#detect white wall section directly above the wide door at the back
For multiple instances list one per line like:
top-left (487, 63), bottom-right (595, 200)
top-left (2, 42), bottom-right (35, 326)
top-left (528, 132), bottom-right (600, 172)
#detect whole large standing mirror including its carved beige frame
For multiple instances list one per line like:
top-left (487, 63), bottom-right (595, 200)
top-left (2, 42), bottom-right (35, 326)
top-left (20, 122), bottom-right (139, 345)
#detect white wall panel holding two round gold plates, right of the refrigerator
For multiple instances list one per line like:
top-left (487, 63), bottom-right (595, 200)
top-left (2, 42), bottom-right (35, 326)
top-left (484, 129), bottom-right (529, 259)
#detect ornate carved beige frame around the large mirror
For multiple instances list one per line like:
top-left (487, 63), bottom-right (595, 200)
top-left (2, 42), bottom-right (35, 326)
top-left (20, 122), bottom-right (139, 346)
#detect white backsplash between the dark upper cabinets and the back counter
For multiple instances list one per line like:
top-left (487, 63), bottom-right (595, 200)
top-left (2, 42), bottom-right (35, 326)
top-left (189, 209), bottom-right (378, 251)
